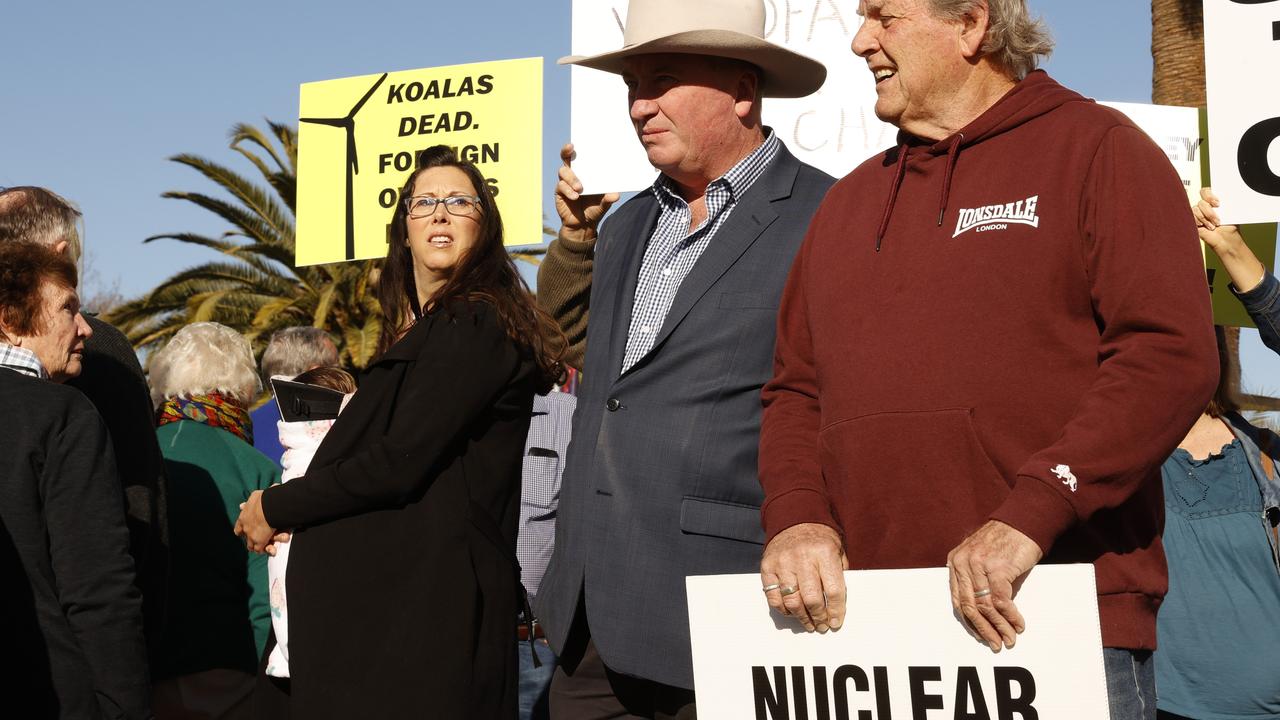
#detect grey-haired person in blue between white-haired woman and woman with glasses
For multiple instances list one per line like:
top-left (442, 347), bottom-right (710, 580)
top-left (250, 325), bottom-right (340, 465)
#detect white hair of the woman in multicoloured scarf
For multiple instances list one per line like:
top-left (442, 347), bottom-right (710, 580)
top-left (150, 323), bottom-right (262, 407)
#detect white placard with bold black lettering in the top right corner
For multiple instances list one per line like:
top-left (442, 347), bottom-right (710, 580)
top-left (1204, 0), bottom-right (1280, 224)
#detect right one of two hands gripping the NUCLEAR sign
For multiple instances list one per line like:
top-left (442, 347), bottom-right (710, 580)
top-left (947, 520), bottom-right (1044, 652)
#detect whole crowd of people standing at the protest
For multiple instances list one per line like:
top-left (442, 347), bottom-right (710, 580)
top-left (0, 0), bottom-right (1280, 720)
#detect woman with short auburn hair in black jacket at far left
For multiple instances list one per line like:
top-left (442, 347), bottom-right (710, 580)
top-left (0, 242), bottom-right (151, 720)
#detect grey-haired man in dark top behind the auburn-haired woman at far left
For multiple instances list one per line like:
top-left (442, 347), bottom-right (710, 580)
top-left (0, 186), bottom-right (169, 656)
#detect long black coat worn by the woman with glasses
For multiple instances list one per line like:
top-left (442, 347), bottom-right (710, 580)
top-left (260, 302), bottom-right (538, 720)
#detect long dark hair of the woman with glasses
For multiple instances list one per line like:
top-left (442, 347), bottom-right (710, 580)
top-left (378, 145), bottom-right (567, 391)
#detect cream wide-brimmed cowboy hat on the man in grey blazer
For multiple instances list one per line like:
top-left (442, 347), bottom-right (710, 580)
top-left (558, 0), bottom-right (827, 97)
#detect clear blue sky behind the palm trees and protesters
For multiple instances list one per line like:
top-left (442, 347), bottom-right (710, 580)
top-left (0, 0), bottom-right (1269, 392)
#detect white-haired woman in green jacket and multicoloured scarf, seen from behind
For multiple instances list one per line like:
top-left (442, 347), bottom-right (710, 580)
top-left (151, 323), bottom-right (280, 720)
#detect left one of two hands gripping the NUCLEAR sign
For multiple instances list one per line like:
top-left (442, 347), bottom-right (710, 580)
top-left (760, 523), bottom-right (849, 633)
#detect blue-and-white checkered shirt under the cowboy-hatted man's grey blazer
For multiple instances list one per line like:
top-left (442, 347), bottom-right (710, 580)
top-left (622, 131), bottom-right (781, 373)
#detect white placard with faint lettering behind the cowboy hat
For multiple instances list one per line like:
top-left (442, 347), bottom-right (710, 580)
top-left (570, 0), bottom-right (897, 192)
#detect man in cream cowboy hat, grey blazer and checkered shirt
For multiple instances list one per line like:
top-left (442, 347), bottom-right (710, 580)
top-left (536, 0), bottom-right (833, 719)
